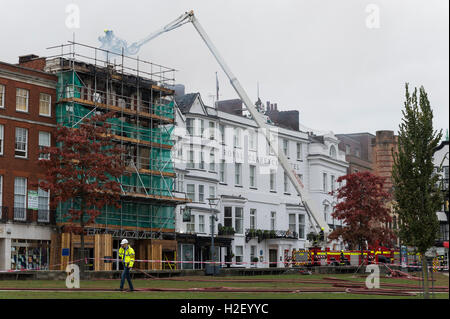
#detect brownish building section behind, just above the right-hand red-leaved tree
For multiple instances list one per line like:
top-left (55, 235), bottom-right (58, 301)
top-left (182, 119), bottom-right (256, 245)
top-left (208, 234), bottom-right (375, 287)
top-left (336, 133), bottom-right (375, 174)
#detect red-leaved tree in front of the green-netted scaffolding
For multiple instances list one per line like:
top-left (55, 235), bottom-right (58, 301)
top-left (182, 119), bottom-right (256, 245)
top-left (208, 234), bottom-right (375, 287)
top-left (39, 113), bottom-right (125, 278)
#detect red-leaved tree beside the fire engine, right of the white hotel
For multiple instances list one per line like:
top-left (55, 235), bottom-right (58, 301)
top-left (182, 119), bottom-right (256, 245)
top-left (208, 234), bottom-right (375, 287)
top-left (328, 172), bottom-right (395, 260)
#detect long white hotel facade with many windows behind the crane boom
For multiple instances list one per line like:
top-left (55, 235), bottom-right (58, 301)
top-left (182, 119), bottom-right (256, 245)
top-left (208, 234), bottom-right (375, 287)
top-left (173, 94), bottom-right (348, 267)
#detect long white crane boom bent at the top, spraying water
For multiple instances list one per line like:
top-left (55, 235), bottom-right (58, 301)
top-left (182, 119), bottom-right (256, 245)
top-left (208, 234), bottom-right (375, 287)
top-left (132, 11), bottom-right (330, 238)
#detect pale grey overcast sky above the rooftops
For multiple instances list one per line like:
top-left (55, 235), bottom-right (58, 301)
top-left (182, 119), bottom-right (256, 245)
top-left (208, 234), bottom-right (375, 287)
top-left (0, 0), bottom-right (449, 134)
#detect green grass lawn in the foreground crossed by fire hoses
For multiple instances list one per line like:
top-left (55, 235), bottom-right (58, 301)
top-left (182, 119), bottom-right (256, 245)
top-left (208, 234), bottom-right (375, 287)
top-left (0, 274), bottom-right (449, 299)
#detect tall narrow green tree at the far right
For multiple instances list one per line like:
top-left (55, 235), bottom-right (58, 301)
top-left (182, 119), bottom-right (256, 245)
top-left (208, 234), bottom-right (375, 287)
top-left (392, 84), bottom-right (443, 298)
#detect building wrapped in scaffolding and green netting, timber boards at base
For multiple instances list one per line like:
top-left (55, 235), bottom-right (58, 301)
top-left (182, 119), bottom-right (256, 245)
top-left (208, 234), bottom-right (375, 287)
top-left (45, 42), bottom-right (186, 270)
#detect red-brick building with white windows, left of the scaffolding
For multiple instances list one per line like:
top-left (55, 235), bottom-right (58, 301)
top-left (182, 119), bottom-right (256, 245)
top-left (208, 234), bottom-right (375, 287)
top-left (0, 55), bottom-right (57, 270)
